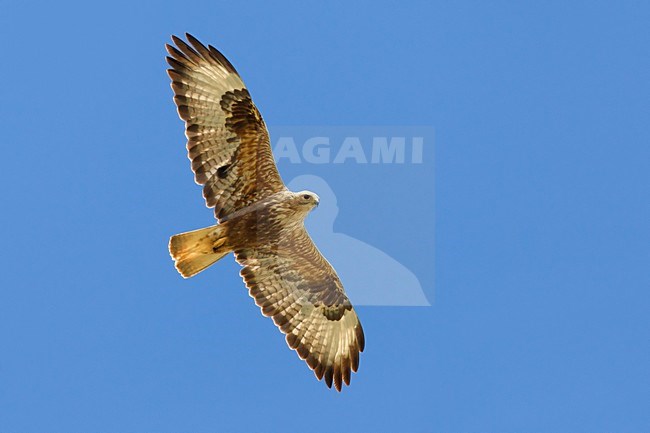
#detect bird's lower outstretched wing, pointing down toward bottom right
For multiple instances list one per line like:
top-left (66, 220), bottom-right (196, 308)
top-left (235, 228), bottom-right (365, 391)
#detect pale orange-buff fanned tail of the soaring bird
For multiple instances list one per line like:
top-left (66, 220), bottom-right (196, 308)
top-left (169, 225), bottom-right (232, 278)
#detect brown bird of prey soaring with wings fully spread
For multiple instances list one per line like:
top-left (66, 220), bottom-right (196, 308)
top-left (166, 34), bottom-right (365, 391)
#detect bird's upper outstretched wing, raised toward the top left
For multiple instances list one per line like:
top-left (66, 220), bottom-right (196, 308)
top-left (166, 34), bottom-right (285, 219)
